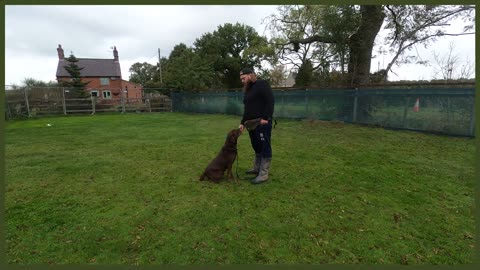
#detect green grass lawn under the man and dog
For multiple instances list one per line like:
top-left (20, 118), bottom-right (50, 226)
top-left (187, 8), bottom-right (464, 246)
top-left (5, 113), bottom-right (475, 265)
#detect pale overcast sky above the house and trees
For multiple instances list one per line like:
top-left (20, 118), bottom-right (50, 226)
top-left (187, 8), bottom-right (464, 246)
top-left (5, 5), bottom-right (475, 85)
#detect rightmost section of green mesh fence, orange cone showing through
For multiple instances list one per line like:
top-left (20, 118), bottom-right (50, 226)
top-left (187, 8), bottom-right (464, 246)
top-left (356, 88), bottom-right (475, 136)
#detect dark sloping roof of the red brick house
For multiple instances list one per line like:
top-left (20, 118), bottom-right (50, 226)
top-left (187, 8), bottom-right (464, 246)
top-left (57, 58), bottom-right (122, 77)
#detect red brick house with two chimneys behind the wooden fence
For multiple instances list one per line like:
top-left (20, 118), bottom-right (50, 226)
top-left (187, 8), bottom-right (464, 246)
top-left (57, 45), bottom-right (143, 103)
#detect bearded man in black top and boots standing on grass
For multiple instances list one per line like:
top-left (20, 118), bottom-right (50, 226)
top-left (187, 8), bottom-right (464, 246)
top-left (239, 68), bottom-right (275, 184)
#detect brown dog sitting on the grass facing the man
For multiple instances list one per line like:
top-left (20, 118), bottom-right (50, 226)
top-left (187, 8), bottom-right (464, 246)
top-left (200, 129), bottom-right (242, 183)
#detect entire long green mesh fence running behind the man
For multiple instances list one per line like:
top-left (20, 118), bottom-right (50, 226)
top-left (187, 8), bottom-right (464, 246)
top-left (171, 88), bottom-right (475, 136)
